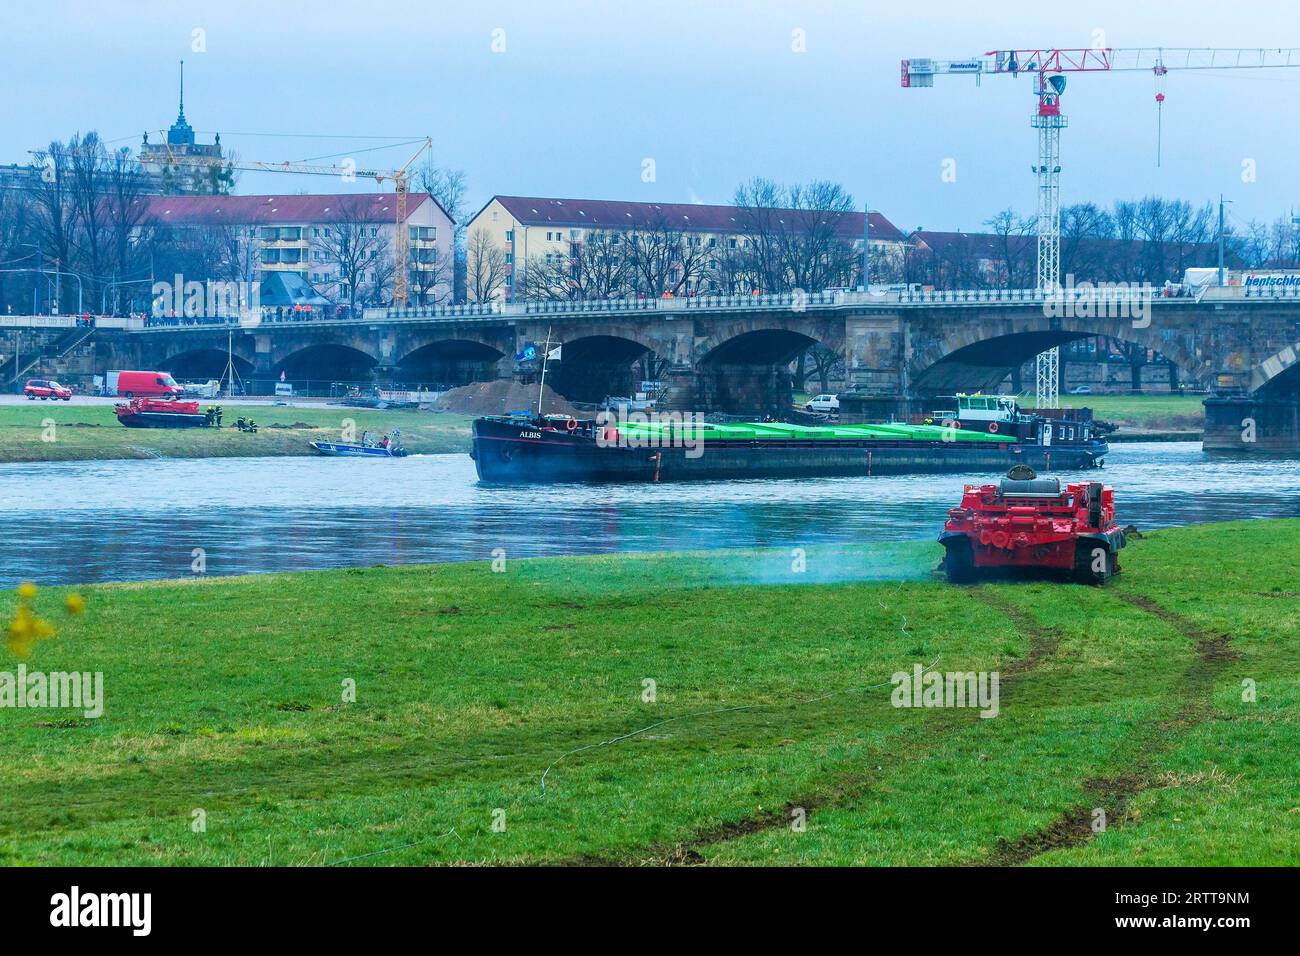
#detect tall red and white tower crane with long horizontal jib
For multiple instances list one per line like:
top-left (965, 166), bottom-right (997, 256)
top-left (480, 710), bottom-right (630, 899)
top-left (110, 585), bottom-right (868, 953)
top-left (902, 47), bottom-right (1300, 408)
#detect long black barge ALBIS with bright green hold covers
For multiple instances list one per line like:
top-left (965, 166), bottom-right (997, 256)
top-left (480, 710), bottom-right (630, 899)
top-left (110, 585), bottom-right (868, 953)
top-left (471, 395), bottom-right (1109, 483)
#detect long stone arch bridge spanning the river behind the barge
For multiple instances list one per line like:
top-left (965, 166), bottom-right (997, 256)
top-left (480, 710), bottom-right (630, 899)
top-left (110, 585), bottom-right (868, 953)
top-left (107, 289), bottom-right (1300, 444)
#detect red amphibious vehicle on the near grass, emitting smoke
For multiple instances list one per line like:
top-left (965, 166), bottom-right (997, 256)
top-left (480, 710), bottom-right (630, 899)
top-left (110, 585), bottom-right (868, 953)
top-left (939, 466), bottom-right (1125, 584)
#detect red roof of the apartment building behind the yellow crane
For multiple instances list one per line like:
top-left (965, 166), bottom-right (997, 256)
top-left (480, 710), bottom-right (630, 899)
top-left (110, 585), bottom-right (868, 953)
top-left (137, 193), bottom-right (441, 225)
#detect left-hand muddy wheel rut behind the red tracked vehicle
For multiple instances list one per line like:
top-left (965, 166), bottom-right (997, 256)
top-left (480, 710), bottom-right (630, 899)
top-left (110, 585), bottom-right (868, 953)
top-left (556, 588), bottom-right (1061, 866)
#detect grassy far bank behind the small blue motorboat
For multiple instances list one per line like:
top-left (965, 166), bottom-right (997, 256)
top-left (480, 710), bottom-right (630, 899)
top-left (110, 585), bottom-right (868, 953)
top-left (0, 402), bottom-right (469, 462)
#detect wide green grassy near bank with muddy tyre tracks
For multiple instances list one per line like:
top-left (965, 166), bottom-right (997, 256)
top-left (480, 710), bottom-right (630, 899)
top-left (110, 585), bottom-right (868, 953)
top-left (0, 520), bottom-right (1300, 865)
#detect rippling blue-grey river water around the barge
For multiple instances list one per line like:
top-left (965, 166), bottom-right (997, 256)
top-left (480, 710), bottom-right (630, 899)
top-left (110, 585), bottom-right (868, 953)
top-left (0, 442), bottom-right (1300, 588)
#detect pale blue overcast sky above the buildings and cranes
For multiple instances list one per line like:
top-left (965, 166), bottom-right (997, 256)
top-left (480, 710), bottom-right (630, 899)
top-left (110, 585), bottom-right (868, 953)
top-left (0, 0), bottom-right (1300, 230)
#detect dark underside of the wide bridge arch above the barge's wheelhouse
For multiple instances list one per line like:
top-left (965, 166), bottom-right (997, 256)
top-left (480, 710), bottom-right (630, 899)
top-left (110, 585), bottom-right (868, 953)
top-left (907, 315), bottom-right (1212, 393)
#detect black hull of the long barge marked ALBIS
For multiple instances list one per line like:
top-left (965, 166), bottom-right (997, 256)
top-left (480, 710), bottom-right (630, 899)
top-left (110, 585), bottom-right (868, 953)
top-left (471, 419), bottom-right (1108, 484)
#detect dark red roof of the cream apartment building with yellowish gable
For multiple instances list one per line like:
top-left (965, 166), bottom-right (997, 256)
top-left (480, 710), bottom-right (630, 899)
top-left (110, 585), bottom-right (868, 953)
top-left (485, 196), bottom-right (904, 242)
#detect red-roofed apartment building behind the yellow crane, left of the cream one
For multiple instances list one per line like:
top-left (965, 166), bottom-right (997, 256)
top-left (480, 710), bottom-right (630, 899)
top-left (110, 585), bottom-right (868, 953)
top-left (140, 193), bottom-right (455, 306)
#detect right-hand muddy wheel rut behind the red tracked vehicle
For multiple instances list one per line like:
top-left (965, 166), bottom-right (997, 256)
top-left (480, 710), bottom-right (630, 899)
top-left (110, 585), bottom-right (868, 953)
top-left (967, 591), bottom-right (1238, 866)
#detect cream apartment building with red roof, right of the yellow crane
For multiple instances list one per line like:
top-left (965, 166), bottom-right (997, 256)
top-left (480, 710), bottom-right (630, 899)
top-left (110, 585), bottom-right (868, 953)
top-left (465, 195), bottom-right (907, 299)
